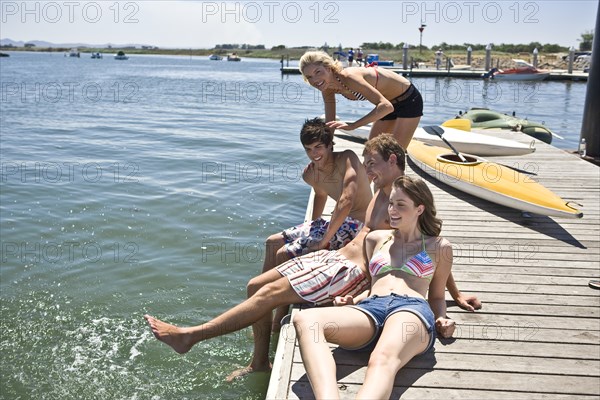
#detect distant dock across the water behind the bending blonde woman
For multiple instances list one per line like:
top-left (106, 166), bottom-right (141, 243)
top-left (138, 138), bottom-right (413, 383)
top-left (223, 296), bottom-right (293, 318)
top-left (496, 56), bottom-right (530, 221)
top-left (280, 66), bottom-right (589, 82)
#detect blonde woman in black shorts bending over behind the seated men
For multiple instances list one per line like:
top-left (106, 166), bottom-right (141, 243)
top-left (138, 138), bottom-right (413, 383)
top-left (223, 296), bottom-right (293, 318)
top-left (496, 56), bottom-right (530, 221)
top-left (300, 51), bottom-right (423, 148)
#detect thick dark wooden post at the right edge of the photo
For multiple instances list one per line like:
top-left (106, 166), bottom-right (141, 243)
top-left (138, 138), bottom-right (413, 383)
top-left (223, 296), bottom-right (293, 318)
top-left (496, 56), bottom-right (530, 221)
top-left (579, 4), bottom-right (600, 160)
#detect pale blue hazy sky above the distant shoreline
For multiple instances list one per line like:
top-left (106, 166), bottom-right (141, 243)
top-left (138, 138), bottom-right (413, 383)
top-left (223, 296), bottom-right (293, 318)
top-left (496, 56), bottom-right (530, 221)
top-left (0, 0), bottom-right (599, 48)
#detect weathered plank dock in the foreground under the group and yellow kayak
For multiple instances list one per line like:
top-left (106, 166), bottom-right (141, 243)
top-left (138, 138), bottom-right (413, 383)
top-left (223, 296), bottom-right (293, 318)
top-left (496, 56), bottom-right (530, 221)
top-left (266, 133), bottom-right (600, 400)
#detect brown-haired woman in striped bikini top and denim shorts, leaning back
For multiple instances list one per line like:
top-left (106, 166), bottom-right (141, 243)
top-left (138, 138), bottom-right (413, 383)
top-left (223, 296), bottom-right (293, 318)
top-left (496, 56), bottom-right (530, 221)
top-left (293, 176), bottom-right (454, 399)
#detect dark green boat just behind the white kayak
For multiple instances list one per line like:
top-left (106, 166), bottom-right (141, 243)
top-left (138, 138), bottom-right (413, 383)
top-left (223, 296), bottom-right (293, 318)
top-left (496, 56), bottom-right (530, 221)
top-left (456, 108), bottom-right (562, 144)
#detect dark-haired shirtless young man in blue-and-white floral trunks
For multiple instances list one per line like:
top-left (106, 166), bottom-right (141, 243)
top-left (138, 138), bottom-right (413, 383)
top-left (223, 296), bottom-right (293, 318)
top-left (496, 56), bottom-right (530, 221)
top-left (266, 118), bottom-right (373, 334)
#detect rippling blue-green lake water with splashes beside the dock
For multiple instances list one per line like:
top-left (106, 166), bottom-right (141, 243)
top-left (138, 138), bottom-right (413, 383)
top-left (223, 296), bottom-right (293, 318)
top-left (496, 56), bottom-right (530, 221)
top-left (0, 52), bottom-right (586, 399)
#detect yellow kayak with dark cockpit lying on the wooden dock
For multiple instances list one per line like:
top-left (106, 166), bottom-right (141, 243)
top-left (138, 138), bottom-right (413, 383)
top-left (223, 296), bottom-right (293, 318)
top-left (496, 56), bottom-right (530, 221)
top-left (407, 140), bottom-right (583, 218)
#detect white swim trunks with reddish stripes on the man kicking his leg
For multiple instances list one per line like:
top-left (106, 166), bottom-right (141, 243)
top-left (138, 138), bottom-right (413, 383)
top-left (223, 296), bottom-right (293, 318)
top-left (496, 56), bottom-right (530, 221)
top-left (277, 250), bottom-right (370, 305)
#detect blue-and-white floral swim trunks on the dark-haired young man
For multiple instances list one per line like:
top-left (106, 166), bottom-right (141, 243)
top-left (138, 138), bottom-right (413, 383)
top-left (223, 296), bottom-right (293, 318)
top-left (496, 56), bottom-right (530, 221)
top-left (281, 217), bottom-right (364, 257)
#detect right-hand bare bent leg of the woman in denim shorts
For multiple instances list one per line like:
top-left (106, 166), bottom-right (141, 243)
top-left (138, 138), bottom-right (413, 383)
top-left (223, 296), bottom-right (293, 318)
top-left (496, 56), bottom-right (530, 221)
top-left (356, 311), bottom-right (429, 399)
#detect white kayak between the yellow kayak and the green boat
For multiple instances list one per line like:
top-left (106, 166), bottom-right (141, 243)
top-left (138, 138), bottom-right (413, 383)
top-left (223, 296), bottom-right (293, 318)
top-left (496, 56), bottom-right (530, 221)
top-left (337, 126), bottom-right (535, 156)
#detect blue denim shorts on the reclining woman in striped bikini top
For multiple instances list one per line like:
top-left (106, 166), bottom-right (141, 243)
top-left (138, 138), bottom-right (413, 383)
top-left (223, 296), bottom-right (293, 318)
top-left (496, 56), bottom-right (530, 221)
top-left (346, 293), bottom-right (435, 354)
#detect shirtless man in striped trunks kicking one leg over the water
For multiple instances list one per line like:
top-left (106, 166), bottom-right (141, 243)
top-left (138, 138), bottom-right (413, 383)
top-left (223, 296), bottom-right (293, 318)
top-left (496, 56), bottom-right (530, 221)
top-left (144, 134), bottom-right (481, 378)
